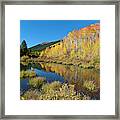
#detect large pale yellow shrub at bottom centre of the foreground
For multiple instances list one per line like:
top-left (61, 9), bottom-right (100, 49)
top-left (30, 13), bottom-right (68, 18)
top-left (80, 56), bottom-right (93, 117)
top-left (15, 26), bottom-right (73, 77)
top-left (39, 82), bottom-right (81, 100)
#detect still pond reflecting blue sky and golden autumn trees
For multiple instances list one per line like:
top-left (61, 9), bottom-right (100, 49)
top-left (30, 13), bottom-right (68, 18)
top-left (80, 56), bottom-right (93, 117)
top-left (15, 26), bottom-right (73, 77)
top-left (20, 62), bottom-right (100, 100)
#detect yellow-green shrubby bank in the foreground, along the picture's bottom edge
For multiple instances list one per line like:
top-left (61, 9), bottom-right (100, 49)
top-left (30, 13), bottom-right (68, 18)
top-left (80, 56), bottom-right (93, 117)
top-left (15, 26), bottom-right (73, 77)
top-left (20, 77), bottom-right (98, 100)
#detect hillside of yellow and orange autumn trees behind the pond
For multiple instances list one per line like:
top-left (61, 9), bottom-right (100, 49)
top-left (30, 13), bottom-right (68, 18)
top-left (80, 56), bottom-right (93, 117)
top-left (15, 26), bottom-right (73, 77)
top-left (39, 23), bottom-right (100, 69)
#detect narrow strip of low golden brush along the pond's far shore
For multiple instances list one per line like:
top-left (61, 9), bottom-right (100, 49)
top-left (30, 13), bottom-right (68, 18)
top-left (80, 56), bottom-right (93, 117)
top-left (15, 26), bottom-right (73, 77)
top-left (20, 56), bottom-right (100, 70)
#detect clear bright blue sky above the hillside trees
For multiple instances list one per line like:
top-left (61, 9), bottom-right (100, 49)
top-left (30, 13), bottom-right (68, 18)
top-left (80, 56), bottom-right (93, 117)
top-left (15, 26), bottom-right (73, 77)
top-left (20, 20), bottom-right (100, 48)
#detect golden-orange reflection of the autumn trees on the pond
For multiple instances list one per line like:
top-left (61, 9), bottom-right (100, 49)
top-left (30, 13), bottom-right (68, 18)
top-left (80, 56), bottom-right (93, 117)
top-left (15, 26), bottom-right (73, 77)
top-left (39, 63), bottom-right (100, 87)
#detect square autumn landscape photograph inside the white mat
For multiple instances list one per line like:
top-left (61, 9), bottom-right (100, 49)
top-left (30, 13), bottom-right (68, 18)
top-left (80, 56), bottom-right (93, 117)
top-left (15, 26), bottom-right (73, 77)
top-left (19, 19), bottom-right (100, 100)
